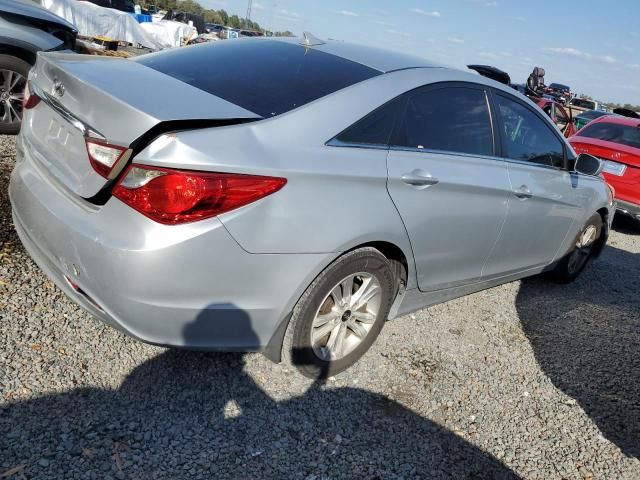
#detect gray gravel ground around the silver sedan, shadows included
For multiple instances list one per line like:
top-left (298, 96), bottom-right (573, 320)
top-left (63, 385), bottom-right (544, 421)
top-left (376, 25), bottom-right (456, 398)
top-left (0, 137), bottom-right (640, 480)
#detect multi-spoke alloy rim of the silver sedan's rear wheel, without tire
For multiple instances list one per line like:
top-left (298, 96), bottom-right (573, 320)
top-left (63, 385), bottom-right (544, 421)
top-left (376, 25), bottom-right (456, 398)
top-left (311, 272), bottom-right (382, 361)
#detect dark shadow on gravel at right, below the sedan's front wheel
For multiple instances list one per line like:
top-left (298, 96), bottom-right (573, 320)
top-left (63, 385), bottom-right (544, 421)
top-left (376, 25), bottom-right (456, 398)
top-left (516, 247), bottom-right (640, 458)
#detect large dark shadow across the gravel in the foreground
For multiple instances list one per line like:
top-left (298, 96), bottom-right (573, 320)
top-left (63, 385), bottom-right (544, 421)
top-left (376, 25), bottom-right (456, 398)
top-left (0, 305), bottom-right (519, 480)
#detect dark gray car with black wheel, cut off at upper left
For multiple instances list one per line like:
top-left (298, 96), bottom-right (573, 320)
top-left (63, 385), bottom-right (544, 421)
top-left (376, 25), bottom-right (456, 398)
top-left (0, 0), bottom-right (78, 135)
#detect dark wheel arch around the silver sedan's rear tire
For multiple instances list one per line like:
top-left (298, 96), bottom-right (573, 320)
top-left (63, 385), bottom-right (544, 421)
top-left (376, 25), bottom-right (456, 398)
top-left (262, 240), bottom-right (415, 363)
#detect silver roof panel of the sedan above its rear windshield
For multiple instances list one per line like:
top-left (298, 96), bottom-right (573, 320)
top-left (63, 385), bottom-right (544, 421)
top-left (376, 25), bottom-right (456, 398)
top-left (276, 37), bottom-right (444, 73)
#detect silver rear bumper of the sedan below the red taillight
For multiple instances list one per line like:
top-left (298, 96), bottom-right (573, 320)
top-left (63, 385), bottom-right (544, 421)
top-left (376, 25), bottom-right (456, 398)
top-left (9, 140), bottom-right (331, 351)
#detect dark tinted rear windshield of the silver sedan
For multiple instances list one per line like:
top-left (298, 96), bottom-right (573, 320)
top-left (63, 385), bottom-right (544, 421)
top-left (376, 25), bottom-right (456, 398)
top-left (135, 39), bottom-right (381, 117)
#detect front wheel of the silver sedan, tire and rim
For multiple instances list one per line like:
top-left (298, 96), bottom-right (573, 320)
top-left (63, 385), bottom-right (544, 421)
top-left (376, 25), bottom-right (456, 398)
top-left (550, 213), bottom-right (602, 283)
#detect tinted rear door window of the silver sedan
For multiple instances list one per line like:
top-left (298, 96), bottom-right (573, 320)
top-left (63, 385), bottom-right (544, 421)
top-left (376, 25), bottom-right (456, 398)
top-left (393, 87), bottom-right (493, 155)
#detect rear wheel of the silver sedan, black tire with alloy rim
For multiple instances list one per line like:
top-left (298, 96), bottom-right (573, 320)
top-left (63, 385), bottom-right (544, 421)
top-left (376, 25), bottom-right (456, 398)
top-left (282, 247), bottom-right (397, 379)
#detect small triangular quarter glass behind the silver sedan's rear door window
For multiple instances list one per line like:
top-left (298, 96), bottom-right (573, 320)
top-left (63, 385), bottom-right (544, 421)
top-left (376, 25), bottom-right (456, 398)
top-left (335, 97), bottom-right (404, 147)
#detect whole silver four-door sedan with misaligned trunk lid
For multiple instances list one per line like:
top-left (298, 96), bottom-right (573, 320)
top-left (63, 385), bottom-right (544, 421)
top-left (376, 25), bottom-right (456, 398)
top-left (9, 39), bottom-right (614, 377)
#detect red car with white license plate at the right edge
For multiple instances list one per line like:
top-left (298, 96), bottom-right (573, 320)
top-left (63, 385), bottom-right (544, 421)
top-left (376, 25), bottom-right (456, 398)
top-left (569, 115), bottom-right (640, 220)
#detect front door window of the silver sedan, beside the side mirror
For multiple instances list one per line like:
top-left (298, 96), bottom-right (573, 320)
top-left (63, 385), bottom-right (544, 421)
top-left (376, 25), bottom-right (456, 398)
top-left (495, 95), bottom-right (564, 168)
